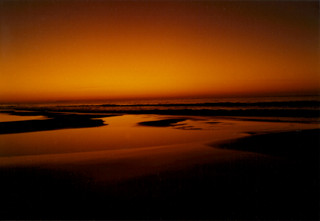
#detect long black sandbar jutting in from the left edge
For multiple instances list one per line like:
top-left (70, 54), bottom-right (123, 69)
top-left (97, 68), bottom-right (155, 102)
top-left (0, 112), bottom-right (112, 134)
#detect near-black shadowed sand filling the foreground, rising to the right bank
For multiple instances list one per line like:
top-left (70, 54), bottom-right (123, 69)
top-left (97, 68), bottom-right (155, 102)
top-left (0, 130), bottom-right (319, 220)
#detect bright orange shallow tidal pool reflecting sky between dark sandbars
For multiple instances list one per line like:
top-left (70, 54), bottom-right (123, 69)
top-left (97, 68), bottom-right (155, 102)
top-left (0, 115), bottom-right (316, 157)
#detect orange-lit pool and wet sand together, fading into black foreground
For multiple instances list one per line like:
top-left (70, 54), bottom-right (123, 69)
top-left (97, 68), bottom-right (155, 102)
top-left (0, 115), bottom-right (318, 184)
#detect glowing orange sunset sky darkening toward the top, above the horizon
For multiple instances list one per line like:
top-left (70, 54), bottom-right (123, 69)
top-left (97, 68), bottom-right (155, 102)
top-left (0, 0), bottom-right (320, 102)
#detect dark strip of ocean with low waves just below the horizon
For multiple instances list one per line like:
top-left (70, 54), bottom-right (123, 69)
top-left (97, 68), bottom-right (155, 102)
top-left (0, 96), bottom-right (320, 117)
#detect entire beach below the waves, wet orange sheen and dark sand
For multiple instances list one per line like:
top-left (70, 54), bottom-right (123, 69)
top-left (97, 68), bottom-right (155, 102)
top-left (0, 106), bottom-right (319, 220)
